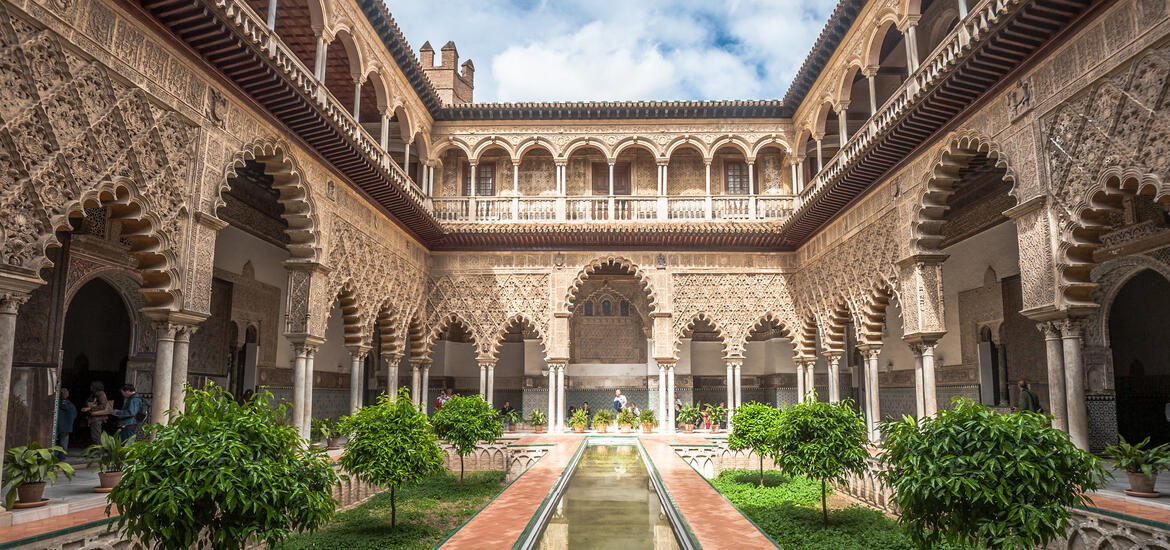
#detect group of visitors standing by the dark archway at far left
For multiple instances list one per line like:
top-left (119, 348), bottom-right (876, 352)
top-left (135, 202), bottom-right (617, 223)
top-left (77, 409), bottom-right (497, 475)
top-left (57, 380), bottom-right (150, 451)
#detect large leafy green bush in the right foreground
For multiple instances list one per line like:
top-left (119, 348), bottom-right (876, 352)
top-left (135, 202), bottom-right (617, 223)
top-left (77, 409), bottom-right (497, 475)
top-left (882, 398), bottom-right (1106, 549)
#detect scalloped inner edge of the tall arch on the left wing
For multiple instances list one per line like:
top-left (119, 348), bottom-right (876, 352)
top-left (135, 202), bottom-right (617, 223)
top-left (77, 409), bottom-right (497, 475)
top-left (222, 138), bottom-right (321, 262)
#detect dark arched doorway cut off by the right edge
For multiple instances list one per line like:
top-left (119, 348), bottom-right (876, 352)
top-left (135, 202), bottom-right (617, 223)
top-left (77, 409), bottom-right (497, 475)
top-left (1109, 269), bottom-right (1170, 445)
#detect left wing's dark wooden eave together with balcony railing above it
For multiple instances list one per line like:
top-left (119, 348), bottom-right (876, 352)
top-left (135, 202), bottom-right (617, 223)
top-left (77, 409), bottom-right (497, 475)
top-left (138, 0), bottom-right (442, 242)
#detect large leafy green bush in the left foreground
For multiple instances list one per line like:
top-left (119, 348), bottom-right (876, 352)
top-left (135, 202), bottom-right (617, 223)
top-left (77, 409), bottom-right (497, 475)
top-left (105, 384), bottom-right (338, 550)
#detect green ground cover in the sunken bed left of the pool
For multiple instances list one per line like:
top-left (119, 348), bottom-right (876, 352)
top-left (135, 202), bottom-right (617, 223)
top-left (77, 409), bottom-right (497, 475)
top-left (277, 472), bottom-right (504, 550)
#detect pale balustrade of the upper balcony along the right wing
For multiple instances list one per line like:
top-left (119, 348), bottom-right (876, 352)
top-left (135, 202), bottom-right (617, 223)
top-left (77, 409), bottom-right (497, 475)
top-left (796, 0), bottom-right (1025, 209)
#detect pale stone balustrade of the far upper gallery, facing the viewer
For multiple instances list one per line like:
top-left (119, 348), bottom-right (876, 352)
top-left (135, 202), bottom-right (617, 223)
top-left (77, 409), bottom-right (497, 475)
top-left (432, 195), bottom-right (794, 224)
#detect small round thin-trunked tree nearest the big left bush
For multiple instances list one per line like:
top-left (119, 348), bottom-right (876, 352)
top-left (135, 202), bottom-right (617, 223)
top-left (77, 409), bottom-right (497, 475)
top-left (340, 389), bottom-right (446, 527)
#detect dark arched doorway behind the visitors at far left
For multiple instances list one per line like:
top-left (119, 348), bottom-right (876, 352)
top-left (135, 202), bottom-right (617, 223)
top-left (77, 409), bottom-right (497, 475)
top-left (61, 277), bottom-right (133, 447)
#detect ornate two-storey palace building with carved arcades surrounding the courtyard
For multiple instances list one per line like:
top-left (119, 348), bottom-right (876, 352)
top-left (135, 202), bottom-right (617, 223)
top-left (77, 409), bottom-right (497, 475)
top-left (0, 0), bottom-right (1170, 472)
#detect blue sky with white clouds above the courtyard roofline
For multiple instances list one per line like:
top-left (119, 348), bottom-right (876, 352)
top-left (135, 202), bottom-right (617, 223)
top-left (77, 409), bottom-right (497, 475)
top-left (386, 0), bottom-right (837, 103)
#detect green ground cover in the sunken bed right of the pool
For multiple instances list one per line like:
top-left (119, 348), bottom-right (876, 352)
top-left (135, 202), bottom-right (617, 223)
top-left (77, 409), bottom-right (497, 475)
top-left (711, 469), bottom-right (955, 550)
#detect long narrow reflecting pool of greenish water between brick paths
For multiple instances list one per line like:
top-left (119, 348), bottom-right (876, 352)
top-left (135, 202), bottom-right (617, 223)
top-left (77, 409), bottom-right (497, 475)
top-left (538, 445), bottom-right (679, 550)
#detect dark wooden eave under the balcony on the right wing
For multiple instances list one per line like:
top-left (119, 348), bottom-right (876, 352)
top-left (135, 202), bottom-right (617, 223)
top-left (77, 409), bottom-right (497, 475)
top-left (780, 0), bottom-right (1101, 249)
